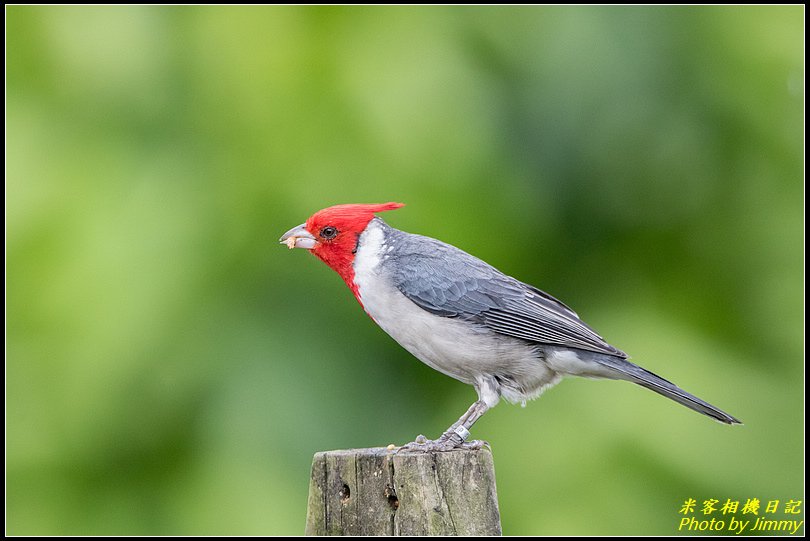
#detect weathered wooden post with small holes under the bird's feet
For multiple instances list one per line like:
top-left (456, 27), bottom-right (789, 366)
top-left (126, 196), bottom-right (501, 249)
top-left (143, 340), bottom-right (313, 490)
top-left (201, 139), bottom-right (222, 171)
top-left (306, 448), bottom-right (501, 535)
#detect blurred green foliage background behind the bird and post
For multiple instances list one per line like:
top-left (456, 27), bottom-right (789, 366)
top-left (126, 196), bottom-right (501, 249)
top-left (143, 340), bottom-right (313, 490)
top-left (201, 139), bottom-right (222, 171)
top-left (6, 6), bottom-right (804, 535)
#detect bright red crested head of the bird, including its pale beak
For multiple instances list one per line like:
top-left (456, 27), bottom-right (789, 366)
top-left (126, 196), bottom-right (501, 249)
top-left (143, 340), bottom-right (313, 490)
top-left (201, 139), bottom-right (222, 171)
top-left (281, 203), bottom-right (404, 300)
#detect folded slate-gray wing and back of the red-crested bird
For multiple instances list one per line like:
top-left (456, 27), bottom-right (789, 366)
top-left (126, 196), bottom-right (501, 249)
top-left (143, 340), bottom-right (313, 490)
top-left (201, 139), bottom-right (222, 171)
top-left (384, 230), bottom-right (627, 358)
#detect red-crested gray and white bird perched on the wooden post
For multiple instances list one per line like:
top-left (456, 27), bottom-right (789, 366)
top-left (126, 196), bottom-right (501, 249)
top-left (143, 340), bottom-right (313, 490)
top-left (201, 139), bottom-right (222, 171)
top-left (279, 202), bottom-right (741, 452)
